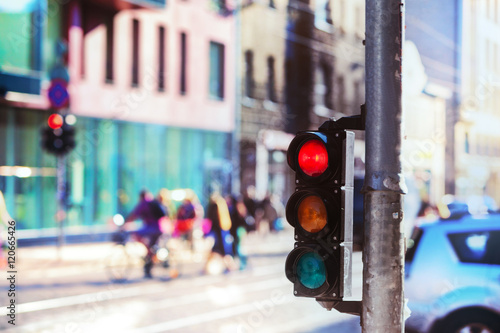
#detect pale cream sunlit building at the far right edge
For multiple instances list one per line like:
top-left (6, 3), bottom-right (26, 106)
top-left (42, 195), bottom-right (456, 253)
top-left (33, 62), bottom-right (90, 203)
top-left (455, 0), bottom-right (500, 203)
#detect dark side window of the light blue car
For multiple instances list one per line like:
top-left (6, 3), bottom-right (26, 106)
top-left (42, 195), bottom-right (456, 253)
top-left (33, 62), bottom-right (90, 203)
top-left (448, 230), bottom-right (500, 265)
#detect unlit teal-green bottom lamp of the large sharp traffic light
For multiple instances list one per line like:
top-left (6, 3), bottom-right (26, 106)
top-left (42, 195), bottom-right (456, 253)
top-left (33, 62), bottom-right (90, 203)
top-left (297, 252), bottom-right (326, 289)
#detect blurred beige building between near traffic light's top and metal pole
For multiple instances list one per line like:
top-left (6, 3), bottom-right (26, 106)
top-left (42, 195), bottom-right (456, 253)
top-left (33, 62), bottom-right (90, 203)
top-left (309, 0), bottom-right (365, 127)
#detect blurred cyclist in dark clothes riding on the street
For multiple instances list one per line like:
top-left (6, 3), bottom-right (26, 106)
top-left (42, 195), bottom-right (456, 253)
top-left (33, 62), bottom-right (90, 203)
top-left (125, 190), bottom-right (165, 279)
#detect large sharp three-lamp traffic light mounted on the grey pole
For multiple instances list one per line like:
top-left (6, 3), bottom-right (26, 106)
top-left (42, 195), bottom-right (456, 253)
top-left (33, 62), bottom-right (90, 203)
top-left (285, 127), bottom-right (354, 308)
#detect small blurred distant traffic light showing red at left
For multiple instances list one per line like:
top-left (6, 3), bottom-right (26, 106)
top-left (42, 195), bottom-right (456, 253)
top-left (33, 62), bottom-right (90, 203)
top-left (41, 113), bottom-right (76, 156)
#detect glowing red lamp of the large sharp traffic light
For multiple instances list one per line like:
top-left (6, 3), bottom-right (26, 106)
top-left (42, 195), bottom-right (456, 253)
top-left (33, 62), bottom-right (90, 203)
top-left (298, 139), bottom-right (328, 177)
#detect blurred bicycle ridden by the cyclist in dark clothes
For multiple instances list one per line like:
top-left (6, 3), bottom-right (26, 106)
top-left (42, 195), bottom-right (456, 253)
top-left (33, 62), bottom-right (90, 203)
top-left (104, 214), bottom-right (181, 283)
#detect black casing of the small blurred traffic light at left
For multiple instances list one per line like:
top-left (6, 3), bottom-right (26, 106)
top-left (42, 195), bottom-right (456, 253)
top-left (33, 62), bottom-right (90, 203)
top-left (41, 115), bottom-right (76, 156)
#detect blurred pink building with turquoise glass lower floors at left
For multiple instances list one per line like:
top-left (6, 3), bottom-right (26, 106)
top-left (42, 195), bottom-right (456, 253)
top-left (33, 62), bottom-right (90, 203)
top-left (0, 0), bottom-right (238, 236)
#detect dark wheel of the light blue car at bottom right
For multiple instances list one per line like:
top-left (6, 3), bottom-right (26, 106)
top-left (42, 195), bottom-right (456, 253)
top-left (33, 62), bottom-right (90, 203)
top-left (441, 310), bottom-right (500, 333)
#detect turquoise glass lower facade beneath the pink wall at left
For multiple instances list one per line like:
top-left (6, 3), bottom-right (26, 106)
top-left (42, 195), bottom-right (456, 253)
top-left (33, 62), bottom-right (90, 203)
top-left (0, 106), bottom-right (232, 230)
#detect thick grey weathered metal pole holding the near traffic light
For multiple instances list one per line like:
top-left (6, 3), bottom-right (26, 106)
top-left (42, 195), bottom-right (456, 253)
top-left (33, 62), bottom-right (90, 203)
top-left (362, 0), bottom-right (405, 333)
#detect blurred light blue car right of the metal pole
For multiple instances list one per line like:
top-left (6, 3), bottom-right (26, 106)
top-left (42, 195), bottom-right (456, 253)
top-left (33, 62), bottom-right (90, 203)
top-left (405, 214), bottom-right (500, 333)
